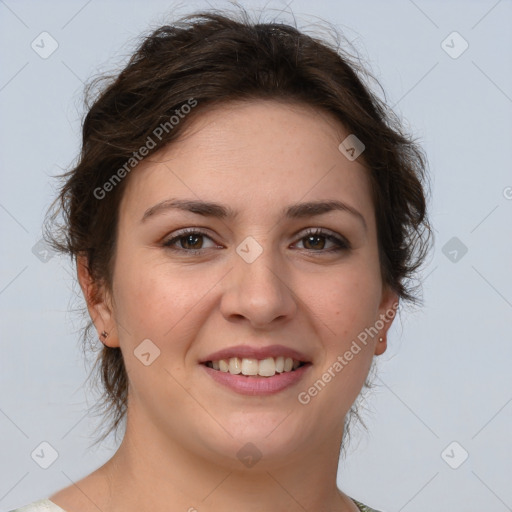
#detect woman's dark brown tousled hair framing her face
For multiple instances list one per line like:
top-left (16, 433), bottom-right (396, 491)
top-left (46, 11), bottom-right (432, 448)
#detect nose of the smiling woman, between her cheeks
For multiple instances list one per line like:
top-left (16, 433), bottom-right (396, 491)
top-left (220, 242), bottom-right (297, 330)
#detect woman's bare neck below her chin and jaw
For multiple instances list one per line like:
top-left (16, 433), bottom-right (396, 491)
top-left (102, 406), bottom-right (357, 512)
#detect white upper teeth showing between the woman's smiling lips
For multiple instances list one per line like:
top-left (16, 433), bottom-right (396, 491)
top-left (202, 356), bottom-right (311, 377)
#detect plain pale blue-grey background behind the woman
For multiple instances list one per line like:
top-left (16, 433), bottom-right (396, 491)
top-left (0, 0), bottom-right (512, 512)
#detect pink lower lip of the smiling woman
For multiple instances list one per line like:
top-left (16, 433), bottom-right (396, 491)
top-left (201, 363), bottom-right (311, 396)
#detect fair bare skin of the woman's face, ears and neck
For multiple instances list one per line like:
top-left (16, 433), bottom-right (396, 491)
top-left (50, 101), bottom-right (398, 512)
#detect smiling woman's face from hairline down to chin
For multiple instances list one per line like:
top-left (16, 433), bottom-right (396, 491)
top-left (88, 101), bottom-right (397, 467)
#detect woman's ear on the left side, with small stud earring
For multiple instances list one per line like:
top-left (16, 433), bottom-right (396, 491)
top-left (76, 254), bottom-right (119, 347)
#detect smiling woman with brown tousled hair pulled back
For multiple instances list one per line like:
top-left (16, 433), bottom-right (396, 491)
top-left (10, 8), bottom-right (431, 512)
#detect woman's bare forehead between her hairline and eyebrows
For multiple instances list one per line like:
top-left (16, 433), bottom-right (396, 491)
top-left (121, 100), bottom-right (373, 225)
